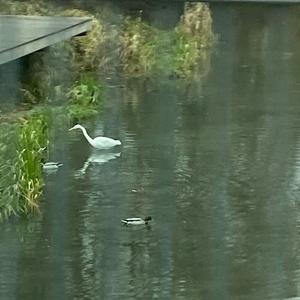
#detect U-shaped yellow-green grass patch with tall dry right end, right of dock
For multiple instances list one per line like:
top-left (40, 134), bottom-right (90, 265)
top-left (120, 3), bottom-right (215, 78)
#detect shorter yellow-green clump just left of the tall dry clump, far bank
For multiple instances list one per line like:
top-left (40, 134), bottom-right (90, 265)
top-left (120, 18), bottom-right (157, 76)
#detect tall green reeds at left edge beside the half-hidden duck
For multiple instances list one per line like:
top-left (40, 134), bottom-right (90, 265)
top-left (0, 115), bottom-right (48, 219)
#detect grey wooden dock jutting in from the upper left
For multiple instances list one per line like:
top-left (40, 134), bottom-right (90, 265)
top-left (0, 15), bottom-right (91, 65)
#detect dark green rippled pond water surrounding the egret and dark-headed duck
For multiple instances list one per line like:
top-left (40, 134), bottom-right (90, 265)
top-left (0, 4), bottom-right (300, 299)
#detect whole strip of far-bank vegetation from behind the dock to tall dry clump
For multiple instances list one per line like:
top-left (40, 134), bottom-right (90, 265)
top-left (0, 0), bottom-right (215, 81)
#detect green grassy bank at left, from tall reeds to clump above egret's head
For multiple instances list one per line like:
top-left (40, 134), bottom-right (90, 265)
top-left (0, 76), bottom-right (103, 219)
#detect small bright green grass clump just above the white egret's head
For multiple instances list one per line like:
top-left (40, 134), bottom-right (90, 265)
top-left (67, 75), bottom-right (104, 121)
